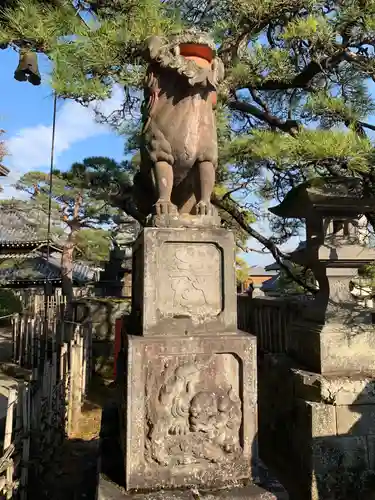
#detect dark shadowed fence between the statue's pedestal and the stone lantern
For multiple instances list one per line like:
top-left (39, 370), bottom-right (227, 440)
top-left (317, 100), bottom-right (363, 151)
top-left (237, 295), bottom-right (301, 353)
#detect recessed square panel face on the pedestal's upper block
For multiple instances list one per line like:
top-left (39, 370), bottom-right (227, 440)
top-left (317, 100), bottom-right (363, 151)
top-left (158, 243), bottom-right (222, 318)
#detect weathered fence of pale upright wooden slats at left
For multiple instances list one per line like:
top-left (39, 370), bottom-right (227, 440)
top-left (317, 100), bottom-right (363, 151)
top-left (0, 314), bottom-right (91, 500)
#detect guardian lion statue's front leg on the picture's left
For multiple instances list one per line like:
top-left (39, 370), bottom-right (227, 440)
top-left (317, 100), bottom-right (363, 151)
top-left (152, 161), bottom-right (178, 215)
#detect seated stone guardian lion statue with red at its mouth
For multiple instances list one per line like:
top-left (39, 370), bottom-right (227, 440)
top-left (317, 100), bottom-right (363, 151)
top-left (134, 31), bottom-right (224, 219)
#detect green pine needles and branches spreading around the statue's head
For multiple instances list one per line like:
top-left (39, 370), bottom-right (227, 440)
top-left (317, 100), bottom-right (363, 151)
top-left (0, 0), bottom-right (375, 258)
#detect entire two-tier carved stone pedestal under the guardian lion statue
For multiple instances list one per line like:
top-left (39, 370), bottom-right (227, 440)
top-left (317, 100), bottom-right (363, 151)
top-left (117, 227), bottom-right (272, 498)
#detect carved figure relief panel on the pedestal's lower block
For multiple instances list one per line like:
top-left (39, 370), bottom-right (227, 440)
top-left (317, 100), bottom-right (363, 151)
top-left (145, 354), bottom-right (242, 466)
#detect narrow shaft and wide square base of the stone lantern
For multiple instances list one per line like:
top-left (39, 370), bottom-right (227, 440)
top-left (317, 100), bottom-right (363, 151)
top-left (289, 267), bottom-right (375, 375)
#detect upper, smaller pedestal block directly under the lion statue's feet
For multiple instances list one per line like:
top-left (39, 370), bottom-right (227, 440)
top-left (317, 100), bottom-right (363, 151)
top-left (127, 227), bottom-right (237, 336)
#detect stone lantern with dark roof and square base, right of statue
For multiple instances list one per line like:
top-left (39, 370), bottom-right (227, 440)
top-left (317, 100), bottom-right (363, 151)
top-left (270, 178), bottom-right (375, 374)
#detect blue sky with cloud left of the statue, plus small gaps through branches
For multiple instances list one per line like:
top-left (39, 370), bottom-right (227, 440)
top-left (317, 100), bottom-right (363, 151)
top-left (0, 49), bottom-right (297, 265)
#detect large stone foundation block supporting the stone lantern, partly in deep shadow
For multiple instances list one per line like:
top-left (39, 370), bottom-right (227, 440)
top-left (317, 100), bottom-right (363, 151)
top-left (258, 354), bottom-right (375, 500)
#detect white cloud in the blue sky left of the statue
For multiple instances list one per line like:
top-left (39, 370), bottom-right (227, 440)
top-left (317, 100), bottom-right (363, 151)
top-left (2, 86), bottom-right (124, 178)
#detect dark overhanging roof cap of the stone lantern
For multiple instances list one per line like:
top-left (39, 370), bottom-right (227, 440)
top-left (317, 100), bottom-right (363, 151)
top-left (269, 177), bottom-right (375, 219)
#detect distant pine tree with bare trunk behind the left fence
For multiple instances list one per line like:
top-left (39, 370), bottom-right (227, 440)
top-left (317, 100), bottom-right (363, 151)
top-left (3, 167), bottom-right (117, 298)
